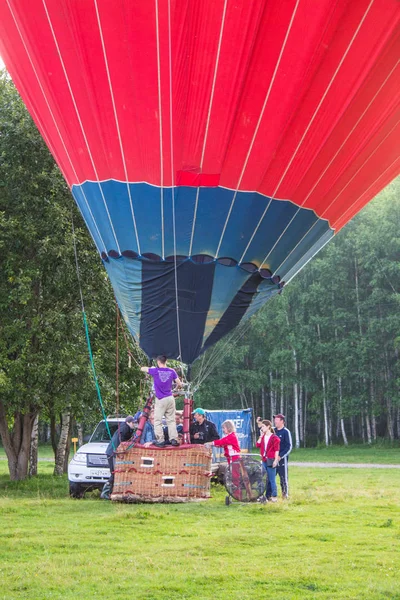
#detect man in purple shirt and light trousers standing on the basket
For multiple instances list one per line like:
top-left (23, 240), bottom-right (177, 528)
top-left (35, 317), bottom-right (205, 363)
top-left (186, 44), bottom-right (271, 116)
top-left (140, 356), bottom-right (181, 447)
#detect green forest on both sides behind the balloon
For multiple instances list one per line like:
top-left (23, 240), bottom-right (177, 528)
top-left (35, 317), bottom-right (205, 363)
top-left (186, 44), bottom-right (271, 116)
top-left (0, 72), bottom-right (400, 479)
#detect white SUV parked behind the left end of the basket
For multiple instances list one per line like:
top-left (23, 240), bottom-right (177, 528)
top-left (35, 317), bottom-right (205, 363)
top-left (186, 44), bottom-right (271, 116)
top-left (68, 417), bottom-right (125, 498)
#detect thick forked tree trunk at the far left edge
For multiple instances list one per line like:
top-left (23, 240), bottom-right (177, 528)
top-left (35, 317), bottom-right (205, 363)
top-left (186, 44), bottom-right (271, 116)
top-left (0, 401), bottom-right (37, 481)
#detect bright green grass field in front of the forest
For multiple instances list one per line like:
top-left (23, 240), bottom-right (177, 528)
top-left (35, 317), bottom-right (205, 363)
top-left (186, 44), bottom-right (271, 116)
top-left (0, 455), bottom-right (400, 600)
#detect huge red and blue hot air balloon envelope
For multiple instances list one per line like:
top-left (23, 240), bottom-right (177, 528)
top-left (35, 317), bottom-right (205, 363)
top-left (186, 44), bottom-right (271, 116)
top-left (0, 0), bottom-right (400, 376)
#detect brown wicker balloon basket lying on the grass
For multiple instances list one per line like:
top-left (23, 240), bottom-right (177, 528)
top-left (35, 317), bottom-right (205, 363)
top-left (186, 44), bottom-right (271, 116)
top-left (111, 442), bottom-right (211, 502)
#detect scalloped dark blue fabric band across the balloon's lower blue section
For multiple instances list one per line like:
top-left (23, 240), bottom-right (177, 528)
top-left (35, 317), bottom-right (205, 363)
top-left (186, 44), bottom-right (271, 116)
top-left (101, 250), bottom-right (285, 287)
